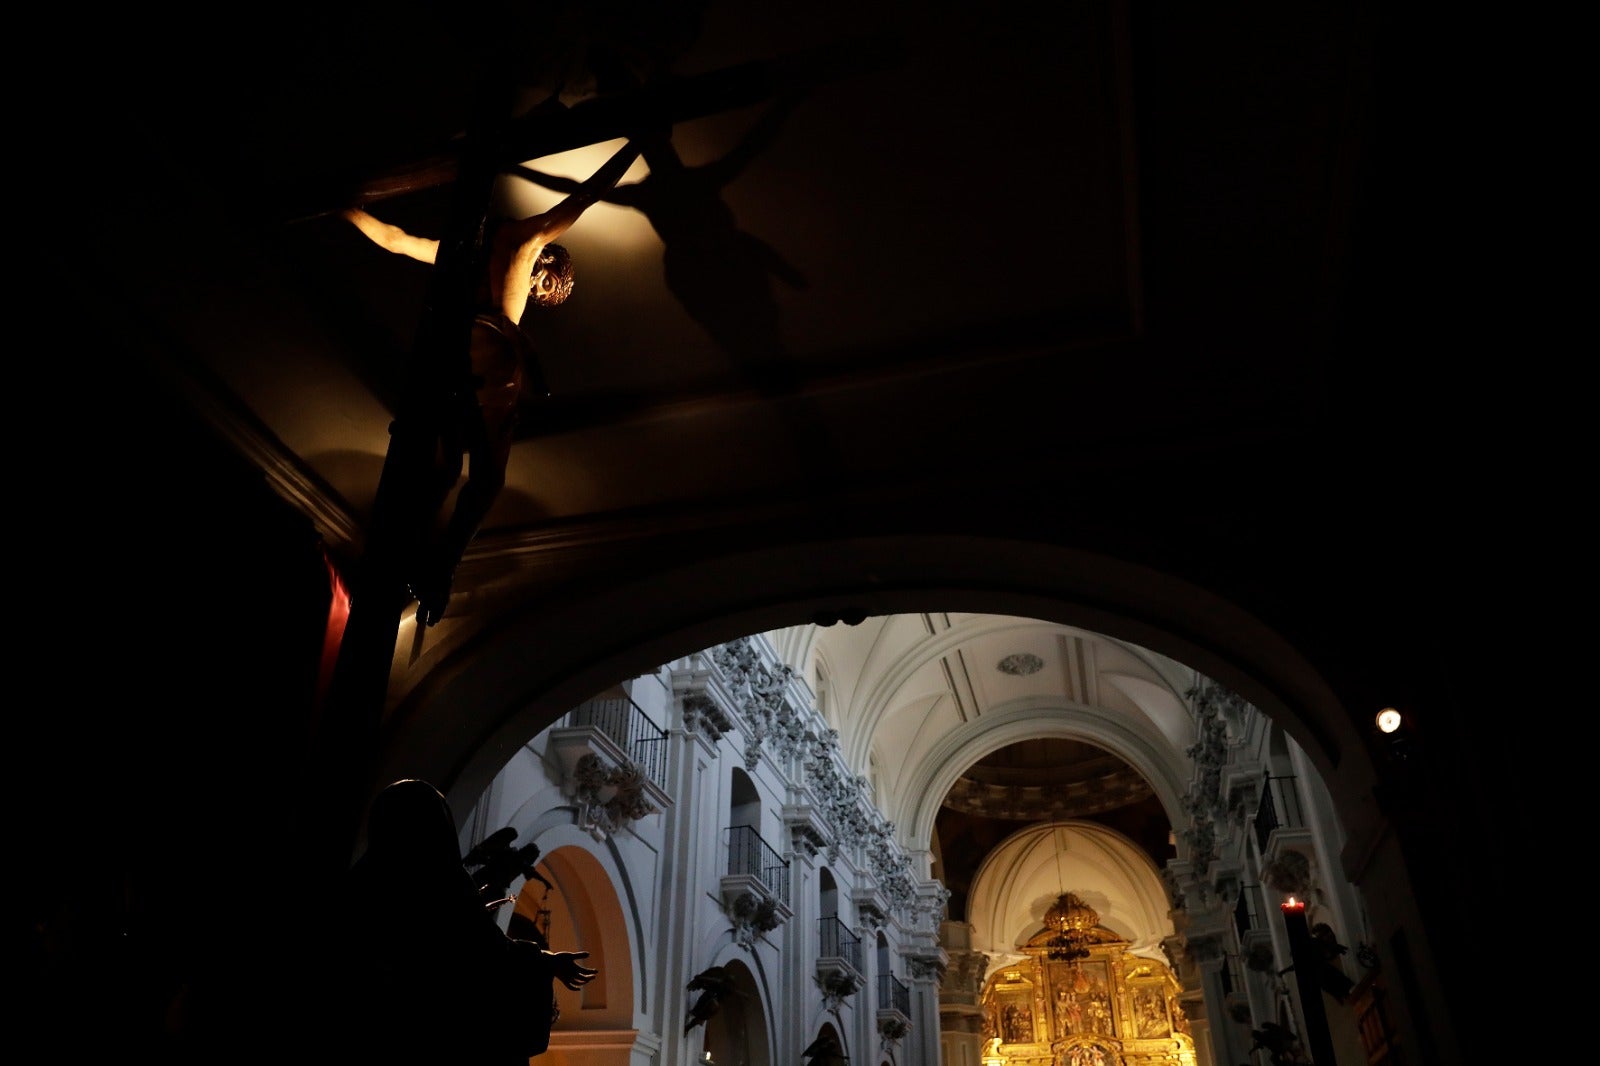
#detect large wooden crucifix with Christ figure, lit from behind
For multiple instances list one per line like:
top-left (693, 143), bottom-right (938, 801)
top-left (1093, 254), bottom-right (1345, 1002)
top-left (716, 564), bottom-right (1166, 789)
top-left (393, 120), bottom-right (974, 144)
top-left (312, 38), bottom-right (898, 877)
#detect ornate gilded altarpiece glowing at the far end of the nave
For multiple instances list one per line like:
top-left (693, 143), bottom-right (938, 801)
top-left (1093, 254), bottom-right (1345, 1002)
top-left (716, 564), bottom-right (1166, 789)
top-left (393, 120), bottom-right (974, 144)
top-left (982, 928), bottom-right (1195, 1066)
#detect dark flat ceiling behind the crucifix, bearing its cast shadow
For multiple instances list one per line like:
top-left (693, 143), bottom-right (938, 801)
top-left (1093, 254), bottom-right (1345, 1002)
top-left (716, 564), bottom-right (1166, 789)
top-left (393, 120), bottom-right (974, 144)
top-left (31, 0), bottom-right (1395, 573)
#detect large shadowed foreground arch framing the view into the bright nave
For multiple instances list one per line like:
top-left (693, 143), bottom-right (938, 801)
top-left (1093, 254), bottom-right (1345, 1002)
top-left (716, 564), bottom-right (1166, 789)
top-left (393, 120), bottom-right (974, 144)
top-left (376, 536), bottom-right (1376, 877)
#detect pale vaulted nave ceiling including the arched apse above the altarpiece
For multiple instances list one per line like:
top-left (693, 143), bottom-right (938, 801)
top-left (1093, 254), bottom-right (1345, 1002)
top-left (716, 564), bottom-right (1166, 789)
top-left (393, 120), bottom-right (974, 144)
top-left (774, 613), bottom-right (1195, 954)
